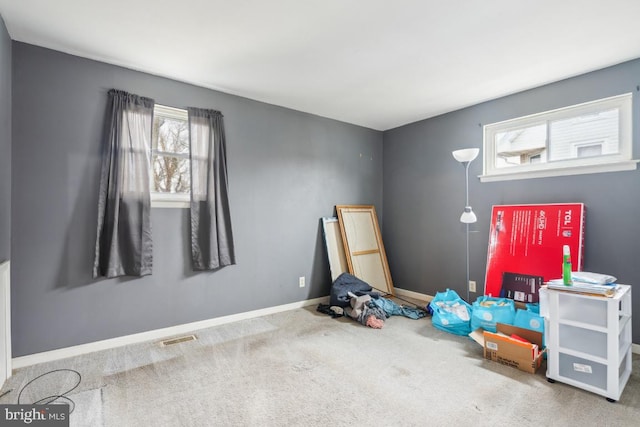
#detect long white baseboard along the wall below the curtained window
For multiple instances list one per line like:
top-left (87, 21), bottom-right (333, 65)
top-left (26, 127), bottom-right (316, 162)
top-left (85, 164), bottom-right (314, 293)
top-left (12, 297), bottom-right (329, 369)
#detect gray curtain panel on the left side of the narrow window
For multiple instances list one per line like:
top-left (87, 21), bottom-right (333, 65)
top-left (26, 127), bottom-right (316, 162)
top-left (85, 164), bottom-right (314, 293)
top-left (93, 89), bottom-right (154, 278)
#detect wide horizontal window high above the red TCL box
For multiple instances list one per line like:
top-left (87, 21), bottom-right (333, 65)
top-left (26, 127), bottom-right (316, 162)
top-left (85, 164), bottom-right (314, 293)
top-left (480, 93), bottom-right (637, 182)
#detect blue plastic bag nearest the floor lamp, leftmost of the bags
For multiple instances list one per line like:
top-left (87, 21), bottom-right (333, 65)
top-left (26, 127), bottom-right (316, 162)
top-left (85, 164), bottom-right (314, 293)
top-left (428, 289), bottom-right (471, 335)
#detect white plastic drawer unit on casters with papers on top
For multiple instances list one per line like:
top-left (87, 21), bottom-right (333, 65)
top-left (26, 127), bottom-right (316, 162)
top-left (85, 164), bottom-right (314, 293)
top-left (540, 285), bottom-right (632, 402)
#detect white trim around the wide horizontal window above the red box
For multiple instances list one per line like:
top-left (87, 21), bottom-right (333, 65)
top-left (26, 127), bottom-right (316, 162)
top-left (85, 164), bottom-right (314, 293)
top-left (479, 93), bottom-right (640, 182)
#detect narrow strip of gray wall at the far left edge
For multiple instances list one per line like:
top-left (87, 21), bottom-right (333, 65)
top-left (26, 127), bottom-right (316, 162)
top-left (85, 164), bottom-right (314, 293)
top-left (0, 16), bottom-right (11, 262)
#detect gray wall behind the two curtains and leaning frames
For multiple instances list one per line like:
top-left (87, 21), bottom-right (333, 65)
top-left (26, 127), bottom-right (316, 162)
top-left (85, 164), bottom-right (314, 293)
top-left (12, 42), bottom-right (382, 357)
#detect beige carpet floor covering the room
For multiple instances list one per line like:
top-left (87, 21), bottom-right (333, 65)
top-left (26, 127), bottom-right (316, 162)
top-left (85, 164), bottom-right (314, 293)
top-left (0, 307), bottom-right (640, 427)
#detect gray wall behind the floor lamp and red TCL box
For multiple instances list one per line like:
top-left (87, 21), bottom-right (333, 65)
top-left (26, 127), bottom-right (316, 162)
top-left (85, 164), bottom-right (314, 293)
top-left (383, 60), bottom-right (640, 343)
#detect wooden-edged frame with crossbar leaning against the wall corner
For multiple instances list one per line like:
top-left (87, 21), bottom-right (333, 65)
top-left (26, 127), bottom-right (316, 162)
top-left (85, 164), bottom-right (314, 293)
top-left (336, 205), bottom-right (394, 295)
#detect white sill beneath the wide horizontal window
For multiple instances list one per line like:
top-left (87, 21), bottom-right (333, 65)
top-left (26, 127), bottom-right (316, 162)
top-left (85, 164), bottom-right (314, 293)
top-left (478, 160), bottom-right (640, 182)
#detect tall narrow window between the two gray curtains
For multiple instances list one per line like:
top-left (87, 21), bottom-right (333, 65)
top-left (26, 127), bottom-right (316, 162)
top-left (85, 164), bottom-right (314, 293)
top-left (150, 104), bottom-right (191, 207)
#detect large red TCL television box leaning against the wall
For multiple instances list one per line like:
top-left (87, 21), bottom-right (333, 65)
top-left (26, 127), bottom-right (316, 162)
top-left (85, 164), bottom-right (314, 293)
top-left (484, 203), bottom-right (585, 297)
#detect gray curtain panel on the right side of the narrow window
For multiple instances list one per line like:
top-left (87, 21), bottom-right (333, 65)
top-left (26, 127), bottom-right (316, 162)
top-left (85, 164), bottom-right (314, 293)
top-left (188, 108), bottom-right (236, 270)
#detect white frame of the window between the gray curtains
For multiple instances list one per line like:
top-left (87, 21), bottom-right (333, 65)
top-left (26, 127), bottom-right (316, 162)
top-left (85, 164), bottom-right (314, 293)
top-left (149, 104), bottom-right (191, 208)
